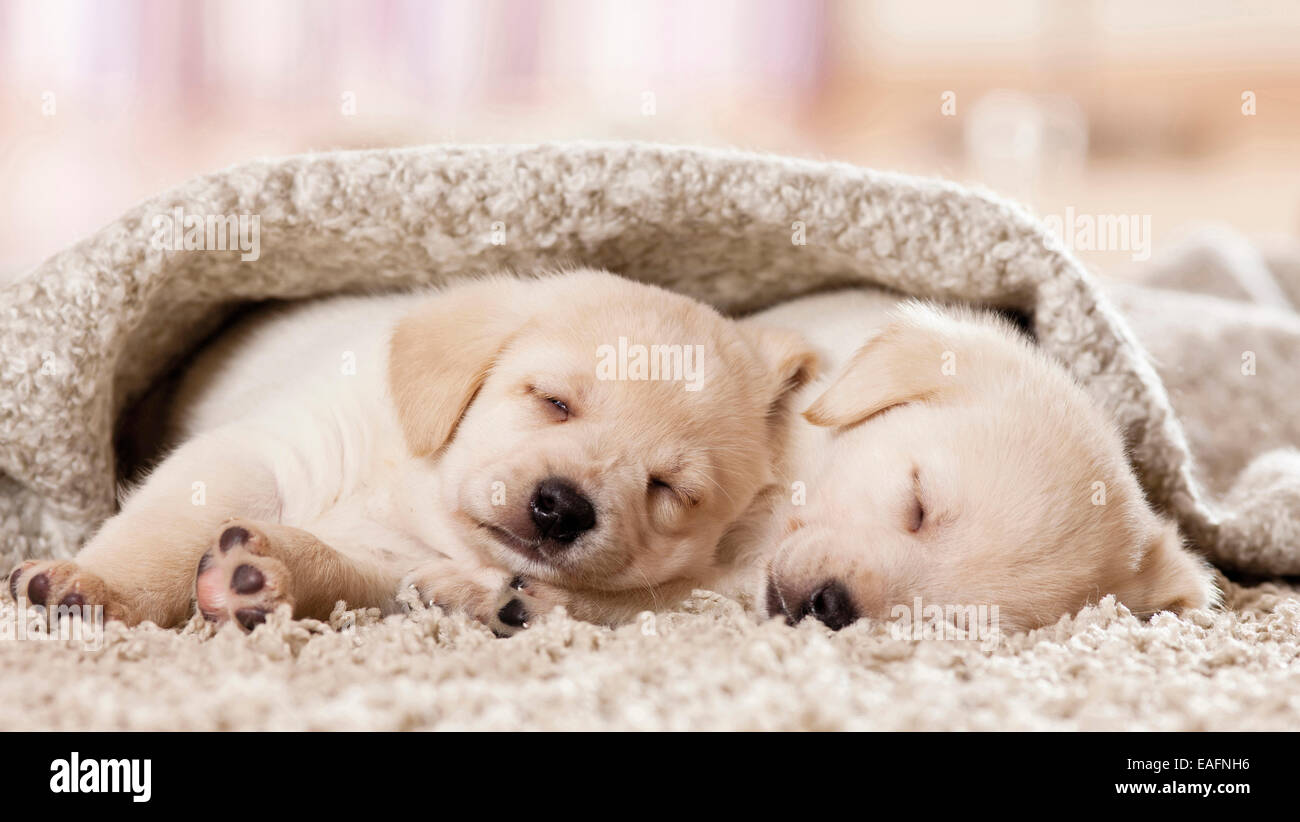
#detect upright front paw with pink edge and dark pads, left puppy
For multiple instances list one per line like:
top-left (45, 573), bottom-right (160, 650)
top-left (194, 519), bottom-right (294, 631)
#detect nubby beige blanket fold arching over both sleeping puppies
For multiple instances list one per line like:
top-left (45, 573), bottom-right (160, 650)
top-left (0, 144), bottom-right (1300, 574)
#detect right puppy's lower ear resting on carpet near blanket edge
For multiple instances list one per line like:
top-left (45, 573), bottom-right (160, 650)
top-left (1118, 522), bottom-right (1218, 617)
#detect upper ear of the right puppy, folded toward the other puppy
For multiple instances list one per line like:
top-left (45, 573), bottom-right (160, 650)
top-left (803, 306), bottom-right (957, 428)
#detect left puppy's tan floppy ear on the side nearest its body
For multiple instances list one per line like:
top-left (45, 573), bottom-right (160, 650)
top-left (389, 277), bottom-right (530, 457)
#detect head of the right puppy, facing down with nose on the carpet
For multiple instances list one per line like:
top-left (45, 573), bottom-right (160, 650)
top-left (764, 304), bottom-right (1216, 630)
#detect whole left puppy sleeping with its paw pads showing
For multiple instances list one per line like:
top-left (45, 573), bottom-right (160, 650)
top-left (9, 271), bottom-right (815, 635)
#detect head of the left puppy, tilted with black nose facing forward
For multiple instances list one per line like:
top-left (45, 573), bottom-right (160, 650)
top-left (389, 271), bottom-right (815, 603)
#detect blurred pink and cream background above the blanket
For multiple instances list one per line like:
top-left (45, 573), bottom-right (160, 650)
top-left (0, 0), bottom-right (1300, 273)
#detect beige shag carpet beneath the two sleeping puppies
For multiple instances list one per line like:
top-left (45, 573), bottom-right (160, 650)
top-left (0, 584), bottom-right (1300, 730)
